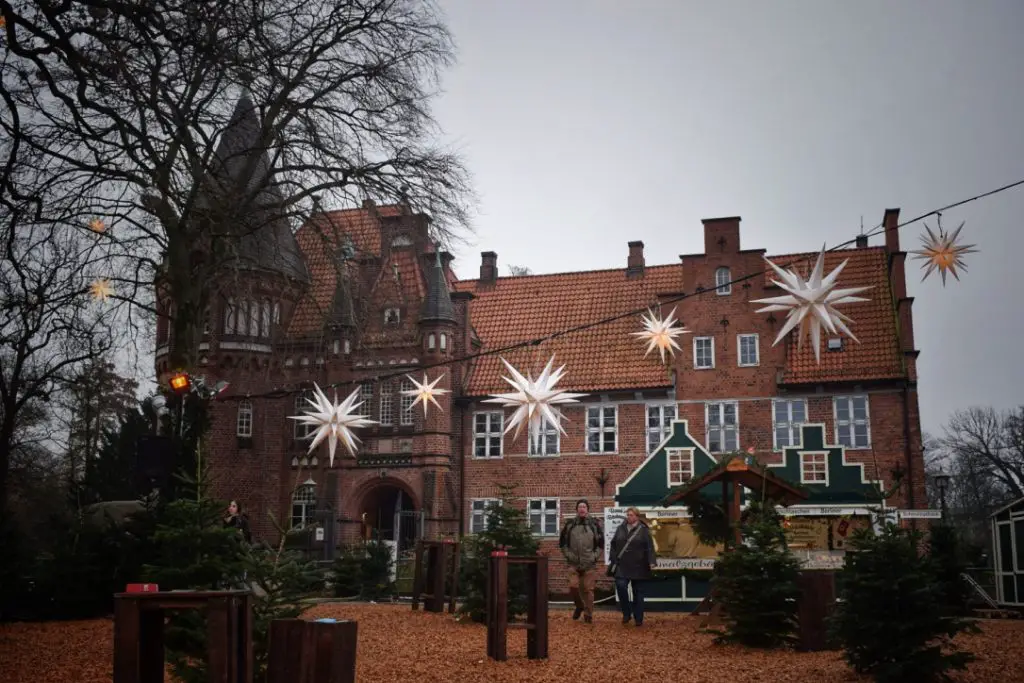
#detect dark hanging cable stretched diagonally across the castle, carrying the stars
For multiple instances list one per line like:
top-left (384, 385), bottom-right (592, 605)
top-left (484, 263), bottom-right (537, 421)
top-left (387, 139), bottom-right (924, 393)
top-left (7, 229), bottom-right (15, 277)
top-left (209, 178), bottom-right (1024, 401)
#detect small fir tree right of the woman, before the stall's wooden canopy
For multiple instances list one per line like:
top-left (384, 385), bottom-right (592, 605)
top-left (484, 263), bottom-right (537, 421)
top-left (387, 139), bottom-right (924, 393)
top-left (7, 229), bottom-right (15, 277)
top-left (713, 503), bottom-right (800, 647)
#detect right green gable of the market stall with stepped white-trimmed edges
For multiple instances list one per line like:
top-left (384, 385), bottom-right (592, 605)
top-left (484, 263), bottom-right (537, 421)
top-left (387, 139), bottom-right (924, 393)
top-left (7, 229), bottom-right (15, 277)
top-left (768, 424), bottom-right (878, 505)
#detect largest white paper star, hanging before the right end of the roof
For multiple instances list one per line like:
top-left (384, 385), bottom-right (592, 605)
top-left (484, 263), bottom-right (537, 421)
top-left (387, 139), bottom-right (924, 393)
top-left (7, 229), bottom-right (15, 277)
top-left (752, 247), bottom-right (871, 364)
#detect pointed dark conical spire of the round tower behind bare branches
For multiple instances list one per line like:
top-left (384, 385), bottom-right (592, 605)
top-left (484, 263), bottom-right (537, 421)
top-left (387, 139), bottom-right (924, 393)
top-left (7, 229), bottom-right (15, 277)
top-left (197, 91), bottom-right (309, 283)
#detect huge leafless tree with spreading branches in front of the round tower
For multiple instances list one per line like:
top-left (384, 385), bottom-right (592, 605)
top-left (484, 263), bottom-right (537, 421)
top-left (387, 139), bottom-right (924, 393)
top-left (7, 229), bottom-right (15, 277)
top-left (0, 0), bottom-right (471, 368)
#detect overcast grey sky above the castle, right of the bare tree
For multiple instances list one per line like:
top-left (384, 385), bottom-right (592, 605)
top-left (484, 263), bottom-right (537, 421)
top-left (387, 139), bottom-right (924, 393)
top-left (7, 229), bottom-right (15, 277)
top-left (435, 0), bottom-right (1024, 433)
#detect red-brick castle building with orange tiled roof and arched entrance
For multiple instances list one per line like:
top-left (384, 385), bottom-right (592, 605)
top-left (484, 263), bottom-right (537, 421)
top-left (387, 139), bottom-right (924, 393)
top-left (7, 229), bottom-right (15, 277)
top-left (157, 92), bottom-right (926, 585)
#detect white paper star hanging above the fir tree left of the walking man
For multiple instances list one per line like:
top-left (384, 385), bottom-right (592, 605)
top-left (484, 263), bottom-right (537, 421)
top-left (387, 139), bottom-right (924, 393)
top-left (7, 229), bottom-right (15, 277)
top-left (483, 356), bottom-right (587, 447)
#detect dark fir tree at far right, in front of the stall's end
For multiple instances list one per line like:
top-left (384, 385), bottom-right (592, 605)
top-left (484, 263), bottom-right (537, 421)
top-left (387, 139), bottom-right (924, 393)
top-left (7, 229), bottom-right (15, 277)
top-left (831, 523), bottom-right (974, 683)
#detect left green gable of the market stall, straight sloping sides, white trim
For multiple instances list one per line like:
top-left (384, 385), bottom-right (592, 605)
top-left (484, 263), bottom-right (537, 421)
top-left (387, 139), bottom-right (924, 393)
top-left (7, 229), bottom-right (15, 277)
top-left (615, 420), bottom-right (722, 507)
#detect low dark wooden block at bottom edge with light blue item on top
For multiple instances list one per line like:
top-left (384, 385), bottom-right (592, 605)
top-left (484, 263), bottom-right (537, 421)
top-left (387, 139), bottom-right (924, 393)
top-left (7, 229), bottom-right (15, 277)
top-left (266, 618), bottom-right (358, 683)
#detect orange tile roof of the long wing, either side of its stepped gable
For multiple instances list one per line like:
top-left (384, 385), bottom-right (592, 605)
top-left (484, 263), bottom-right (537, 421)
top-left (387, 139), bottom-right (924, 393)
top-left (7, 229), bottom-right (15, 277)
top-left (456, 248), bottom-right (903, 395)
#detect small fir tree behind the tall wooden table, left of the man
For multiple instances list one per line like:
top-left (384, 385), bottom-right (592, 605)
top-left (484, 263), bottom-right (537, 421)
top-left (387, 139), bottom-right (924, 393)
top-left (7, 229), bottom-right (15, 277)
top-left (460, 486), bottom-right (540, 623)
